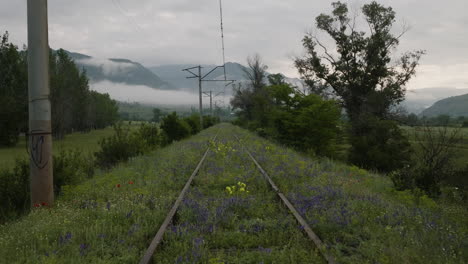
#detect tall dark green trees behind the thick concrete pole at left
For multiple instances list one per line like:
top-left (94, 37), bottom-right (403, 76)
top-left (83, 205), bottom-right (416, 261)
top-left (0, 32), bottom-right (118, 146)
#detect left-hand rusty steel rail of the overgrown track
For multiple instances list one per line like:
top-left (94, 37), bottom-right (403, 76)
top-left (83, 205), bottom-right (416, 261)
top-left (140, 130), bottom-right (219, 264)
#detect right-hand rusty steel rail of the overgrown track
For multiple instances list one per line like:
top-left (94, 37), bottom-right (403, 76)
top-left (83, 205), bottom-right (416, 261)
top-left (234, 135), bottom-right (335, 264)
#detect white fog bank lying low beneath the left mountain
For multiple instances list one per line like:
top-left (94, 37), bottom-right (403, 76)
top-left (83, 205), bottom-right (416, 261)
top-left (90, 81), bottom-right (198, 105)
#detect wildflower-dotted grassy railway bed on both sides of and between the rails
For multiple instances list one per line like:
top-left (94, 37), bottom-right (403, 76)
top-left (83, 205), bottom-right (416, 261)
top-left (0, 124), bottom-right (468, 263)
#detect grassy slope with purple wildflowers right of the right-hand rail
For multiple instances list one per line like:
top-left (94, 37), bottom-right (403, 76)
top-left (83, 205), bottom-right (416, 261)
top-left (237, 126), bottom-right (468, 263)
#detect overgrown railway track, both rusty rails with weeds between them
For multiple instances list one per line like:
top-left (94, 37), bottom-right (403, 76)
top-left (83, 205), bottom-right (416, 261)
top-left (140, 131), bottom-right (335, 264)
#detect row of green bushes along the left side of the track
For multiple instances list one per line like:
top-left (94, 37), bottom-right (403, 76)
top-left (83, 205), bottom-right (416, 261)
top-left (0, 112), bottom-right (218, 222)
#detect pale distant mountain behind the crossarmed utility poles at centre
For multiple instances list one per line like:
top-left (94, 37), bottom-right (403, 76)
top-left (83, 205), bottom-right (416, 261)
top-left (149, 62), bottom-right (303, 95)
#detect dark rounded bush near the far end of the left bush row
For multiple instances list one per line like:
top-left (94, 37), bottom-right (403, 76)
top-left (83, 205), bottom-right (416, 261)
top-left (161, 112), bottom-right (192, 144)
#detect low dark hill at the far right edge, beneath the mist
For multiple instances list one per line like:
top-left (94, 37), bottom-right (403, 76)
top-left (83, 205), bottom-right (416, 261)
top-left (421, 94), bottom-right (468, 117)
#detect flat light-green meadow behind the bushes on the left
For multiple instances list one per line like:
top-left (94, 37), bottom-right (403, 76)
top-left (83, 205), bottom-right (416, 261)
top-left (0, 122), bottom-right (139, 168)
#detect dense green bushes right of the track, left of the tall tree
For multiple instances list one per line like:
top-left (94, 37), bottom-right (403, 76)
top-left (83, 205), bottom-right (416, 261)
top-left (231, 63), bottom-right (340, 156)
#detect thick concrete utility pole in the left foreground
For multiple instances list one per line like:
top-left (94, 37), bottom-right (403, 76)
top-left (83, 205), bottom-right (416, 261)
top-left (28, 0), bottom-right (54, 206)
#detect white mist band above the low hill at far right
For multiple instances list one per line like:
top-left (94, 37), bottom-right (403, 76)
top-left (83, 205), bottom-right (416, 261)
top-left (401, 87), bottom-right (468, 114)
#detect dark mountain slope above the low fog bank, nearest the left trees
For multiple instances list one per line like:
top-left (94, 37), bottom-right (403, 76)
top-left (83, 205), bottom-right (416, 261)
top-left (62, 51), bottom-right (175, 90)
